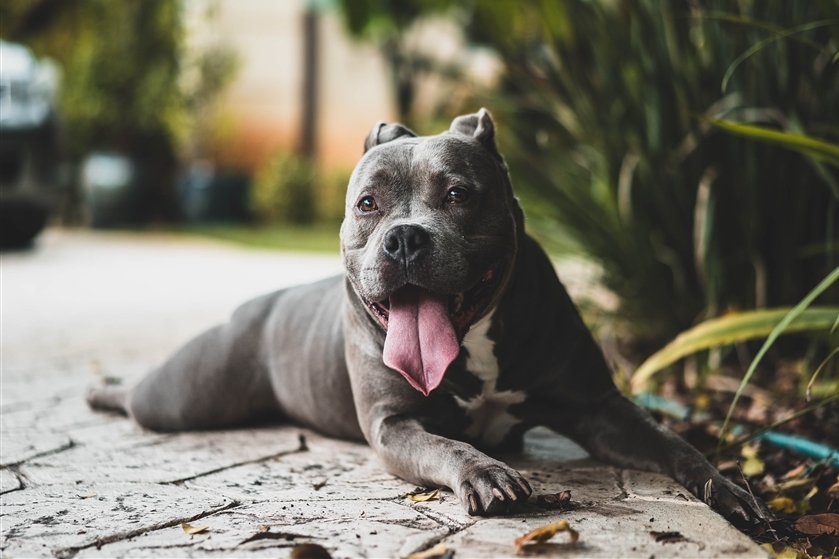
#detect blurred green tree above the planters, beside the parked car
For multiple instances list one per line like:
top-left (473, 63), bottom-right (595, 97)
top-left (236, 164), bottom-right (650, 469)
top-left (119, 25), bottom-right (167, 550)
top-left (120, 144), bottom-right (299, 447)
top-left (0, 0), bottom-right (183, 223)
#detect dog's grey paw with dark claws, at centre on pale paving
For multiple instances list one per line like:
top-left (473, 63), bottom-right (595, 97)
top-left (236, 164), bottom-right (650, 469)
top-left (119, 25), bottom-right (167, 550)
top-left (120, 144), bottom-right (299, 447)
top-left (457, 460), bottom-right (533, 516)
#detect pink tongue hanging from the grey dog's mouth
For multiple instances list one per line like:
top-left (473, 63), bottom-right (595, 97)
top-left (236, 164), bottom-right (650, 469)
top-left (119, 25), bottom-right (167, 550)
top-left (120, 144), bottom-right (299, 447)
top-left (383, 285), bottom-right (460, 396)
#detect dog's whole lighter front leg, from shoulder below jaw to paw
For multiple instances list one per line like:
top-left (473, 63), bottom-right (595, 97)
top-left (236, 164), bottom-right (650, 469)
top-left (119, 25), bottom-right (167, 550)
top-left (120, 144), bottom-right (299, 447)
top-left (345, 307), bottom-right (531, 515)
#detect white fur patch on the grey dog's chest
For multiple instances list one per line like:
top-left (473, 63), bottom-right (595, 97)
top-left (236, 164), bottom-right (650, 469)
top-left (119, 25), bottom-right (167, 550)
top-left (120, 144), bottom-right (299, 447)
top-left (455, 313), bottom-right (525, 445)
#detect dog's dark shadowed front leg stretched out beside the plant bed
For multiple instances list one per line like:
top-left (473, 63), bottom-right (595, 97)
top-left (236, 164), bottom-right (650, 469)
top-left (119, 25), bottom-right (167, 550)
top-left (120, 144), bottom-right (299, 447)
top-left (551, 390), bottom-right (773, 523)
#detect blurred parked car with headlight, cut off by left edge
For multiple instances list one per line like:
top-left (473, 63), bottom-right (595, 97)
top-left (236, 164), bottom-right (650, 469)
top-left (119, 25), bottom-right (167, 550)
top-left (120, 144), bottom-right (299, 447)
top-left (0, 41), bottom-right (59, 247)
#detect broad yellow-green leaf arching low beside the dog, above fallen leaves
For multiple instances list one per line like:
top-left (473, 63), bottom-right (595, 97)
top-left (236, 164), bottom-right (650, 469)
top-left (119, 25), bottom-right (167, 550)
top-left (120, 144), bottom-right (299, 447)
top-left (631, 307), bottom-right (839, 393)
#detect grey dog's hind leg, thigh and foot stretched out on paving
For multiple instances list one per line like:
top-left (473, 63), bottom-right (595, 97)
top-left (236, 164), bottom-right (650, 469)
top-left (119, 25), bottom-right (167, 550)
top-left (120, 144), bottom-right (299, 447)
top-left (88, 292), bottom-right (281, 431)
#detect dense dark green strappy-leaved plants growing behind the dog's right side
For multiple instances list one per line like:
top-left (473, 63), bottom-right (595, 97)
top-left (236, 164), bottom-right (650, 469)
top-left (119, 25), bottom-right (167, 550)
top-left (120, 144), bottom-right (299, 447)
top-left (343, 0), bottom-right (839, 352)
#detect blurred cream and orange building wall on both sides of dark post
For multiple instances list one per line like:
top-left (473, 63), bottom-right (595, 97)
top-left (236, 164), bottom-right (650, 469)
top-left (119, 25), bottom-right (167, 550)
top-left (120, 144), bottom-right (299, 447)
top-left (185, 0), bottom-right (396, 171)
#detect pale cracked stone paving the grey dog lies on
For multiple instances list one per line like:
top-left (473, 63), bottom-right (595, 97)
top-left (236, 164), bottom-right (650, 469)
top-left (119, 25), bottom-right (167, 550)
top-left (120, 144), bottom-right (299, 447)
top-left (0, 230), bottom-right (765, 559)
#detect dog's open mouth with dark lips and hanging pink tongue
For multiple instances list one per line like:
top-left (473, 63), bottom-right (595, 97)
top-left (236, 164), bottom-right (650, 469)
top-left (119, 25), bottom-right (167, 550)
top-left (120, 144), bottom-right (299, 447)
top-left (367, 270), bottom-right (499, 396)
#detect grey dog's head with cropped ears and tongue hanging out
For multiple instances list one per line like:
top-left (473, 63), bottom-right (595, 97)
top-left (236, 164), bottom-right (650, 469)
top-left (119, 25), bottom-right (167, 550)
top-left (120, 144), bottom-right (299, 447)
top-left (341, 109), bottom-right (522, 395)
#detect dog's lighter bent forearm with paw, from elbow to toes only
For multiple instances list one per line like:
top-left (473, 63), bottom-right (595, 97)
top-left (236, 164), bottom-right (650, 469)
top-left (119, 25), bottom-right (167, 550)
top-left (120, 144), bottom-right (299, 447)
top-left (370, 415), bottom-right (531, 515)
